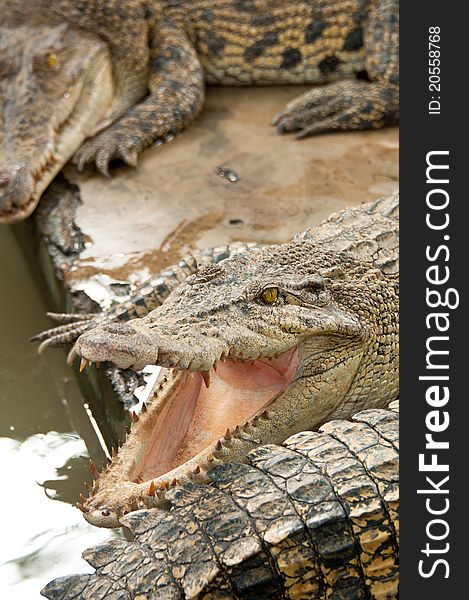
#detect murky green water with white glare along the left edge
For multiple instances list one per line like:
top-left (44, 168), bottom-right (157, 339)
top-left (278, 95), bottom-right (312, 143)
top-left (0, 227), bottom-right (116, 600)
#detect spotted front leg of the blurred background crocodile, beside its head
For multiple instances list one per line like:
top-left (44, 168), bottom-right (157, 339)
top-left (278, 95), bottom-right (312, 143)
top-left (74, 17), bottom-right (204, 176)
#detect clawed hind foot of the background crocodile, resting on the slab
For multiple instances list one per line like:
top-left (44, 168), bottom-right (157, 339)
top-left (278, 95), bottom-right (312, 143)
top-left (272, 80), bottom-right (398, 138)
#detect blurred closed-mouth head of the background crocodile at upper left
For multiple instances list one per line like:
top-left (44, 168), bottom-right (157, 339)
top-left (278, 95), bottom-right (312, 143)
top-left (0, 25), bottom-right (114, 223)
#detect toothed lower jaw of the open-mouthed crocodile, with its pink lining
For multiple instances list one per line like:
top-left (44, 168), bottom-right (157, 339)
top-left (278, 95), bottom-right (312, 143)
top-left (79, 347), bottom-right (300, 527)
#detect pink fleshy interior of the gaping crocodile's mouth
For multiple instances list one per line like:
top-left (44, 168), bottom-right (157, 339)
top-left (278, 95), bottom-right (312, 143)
top-left (132, 349), bottom-right (298, 482)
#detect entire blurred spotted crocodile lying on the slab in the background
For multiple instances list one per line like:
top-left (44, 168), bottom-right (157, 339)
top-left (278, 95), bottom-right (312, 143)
top-left (0, 0), bottom-right (398, 222)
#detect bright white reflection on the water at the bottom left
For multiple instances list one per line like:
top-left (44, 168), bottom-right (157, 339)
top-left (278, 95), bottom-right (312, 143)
top-left (0, 431), bottom-right (119, 600)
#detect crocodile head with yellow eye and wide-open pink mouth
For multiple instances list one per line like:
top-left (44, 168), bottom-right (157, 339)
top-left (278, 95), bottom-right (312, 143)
top-left (76, 242), bottom-right (397, 527)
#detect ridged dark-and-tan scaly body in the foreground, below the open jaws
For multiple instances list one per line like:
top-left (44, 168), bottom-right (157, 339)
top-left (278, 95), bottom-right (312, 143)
top-left (41, 403), bottom-right (399, 600)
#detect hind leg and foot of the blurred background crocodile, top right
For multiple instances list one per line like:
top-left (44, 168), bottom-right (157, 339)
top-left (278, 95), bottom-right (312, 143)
top-left (273, 0), bottom-right (399, 138)
